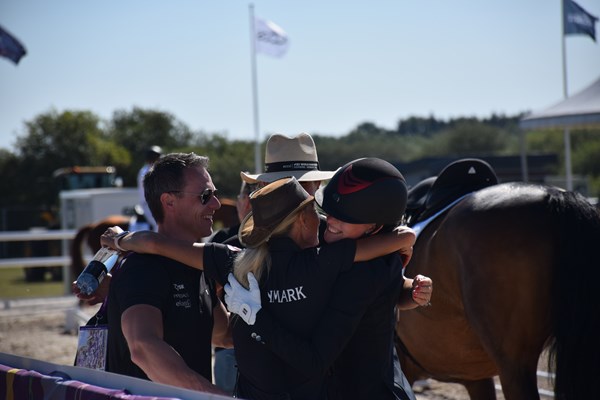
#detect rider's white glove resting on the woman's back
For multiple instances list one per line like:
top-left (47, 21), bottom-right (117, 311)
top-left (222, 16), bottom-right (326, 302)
top-left (224, 272), bottom-right (262, 325)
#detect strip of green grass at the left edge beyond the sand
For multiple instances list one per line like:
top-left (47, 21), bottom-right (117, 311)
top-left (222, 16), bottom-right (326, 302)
top-left (0, 268), bottom-right (65, 299)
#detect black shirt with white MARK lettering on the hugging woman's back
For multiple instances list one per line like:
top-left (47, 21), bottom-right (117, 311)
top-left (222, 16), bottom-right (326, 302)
top-left (203, 238), bottom-right (356, 399)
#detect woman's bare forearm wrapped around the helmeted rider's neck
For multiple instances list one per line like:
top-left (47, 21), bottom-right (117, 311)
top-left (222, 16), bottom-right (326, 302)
top-left (354, 226), bottom-right (417, 265)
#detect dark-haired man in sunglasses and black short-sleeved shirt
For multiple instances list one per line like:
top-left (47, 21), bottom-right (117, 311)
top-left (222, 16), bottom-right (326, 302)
top-left (106, 153), bottom-right (232, 394)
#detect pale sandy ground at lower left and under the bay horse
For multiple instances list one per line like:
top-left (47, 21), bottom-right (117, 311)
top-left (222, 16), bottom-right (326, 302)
top-left (0, 305), bottom-right (503, 400)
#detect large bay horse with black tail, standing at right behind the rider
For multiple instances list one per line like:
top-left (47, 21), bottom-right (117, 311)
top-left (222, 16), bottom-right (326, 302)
top-left (396, 165), bottom-right (600, 400)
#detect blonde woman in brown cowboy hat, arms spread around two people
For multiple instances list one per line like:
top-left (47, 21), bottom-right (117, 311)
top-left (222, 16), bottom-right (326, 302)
top-left (102, 177), bottom-right (415, 399)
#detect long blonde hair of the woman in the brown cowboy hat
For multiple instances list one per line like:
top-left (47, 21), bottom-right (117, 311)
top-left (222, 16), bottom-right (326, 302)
top-left (233, 202), bottom-right (314, 289)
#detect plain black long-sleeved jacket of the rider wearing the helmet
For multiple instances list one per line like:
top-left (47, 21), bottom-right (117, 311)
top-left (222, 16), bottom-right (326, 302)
top-left (246, 254), bottom-right (404, 399)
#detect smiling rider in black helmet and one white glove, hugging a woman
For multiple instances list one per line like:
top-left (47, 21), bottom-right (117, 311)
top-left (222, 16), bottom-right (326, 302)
top-left (225, 158), bottom-right (432, 399)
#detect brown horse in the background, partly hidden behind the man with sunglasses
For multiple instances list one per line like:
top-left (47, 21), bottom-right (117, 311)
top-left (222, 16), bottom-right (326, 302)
top-left (70, 198), bottom-right (239, 281)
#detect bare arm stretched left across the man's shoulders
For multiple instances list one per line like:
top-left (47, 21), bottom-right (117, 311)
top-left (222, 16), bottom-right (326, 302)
top-left (100, 226), bottom-right (204, 269)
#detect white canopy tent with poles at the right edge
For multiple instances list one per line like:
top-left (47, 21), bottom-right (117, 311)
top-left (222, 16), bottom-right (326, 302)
top-left (519, 78), bottom-right (600, 190)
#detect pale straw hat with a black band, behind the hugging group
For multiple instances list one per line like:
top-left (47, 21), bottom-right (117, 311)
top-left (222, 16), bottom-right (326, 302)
top-left (240, 132), bottom-right (335, 183)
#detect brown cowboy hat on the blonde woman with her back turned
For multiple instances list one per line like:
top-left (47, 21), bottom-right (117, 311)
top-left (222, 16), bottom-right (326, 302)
top-left (238, 177), bottom-right (314, 247)
